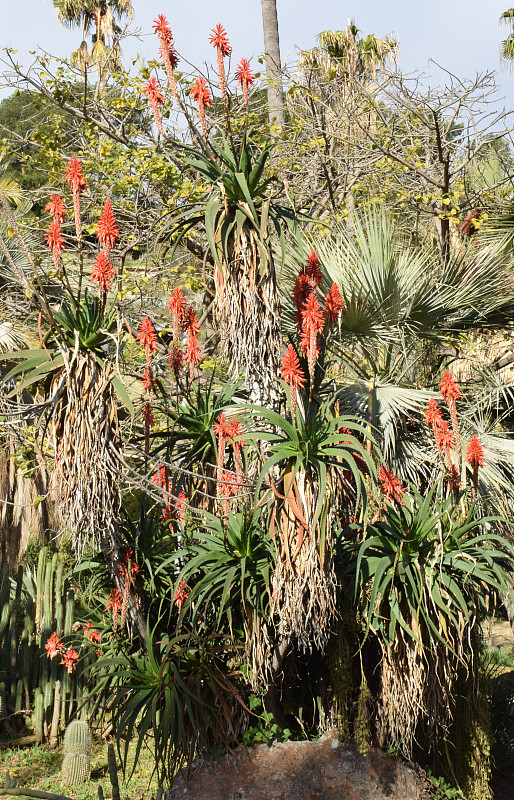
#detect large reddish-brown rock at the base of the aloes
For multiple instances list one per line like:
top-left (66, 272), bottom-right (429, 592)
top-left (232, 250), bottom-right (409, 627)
top-left (169, 731), bottom-right (432, 800)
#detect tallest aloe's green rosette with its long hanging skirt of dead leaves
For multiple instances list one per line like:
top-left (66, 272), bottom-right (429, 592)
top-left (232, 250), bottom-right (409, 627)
top-left (175, 137), bottom-right (295, 409)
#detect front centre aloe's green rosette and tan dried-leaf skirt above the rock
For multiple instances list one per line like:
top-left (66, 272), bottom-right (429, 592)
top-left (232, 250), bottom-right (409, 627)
top-left (245, 403), bottom-right (375, 651)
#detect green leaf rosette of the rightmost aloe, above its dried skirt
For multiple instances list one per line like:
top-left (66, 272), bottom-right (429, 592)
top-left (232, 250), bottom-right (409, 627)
top-left (346, 483), bottom-right (514, 650)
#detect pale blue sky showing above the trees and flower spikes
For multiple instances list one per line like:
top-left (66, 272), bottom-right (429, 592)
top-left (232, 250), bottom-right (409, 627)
top-left (0, 0), bottom-right (514, 110)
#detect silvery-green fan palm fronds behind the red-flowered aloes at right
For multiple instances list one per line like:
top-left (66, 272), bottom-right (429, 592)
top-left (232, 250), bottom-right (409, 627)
top-left (279, 211), bottom-right (514, 502)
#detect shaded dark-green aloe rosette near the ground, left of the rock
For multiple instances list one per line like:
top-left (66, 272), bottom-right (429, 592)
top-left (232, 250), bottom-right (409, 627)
top-left (95, 630), bottom-right (246, 785)
